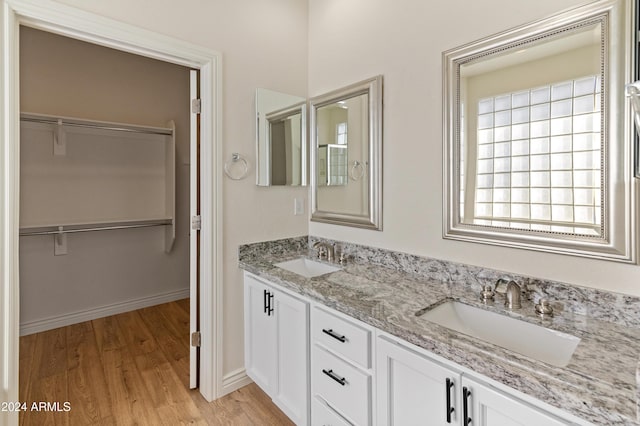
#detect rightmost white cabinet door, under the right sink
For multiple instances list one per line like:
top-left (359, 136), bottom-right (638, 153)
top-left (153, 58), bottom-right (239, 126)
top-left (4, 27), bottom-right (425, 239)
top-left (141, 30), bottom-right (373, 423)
top-left (462, 376), bottom-right (571, 426)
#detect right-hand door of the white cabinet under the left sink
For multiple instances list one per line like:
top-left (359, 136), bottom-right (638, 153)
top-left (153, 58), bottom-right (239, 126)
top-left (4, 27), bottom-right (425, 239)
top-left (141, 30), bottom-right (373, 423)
top-left (272, 290), bottom-right (309, 425)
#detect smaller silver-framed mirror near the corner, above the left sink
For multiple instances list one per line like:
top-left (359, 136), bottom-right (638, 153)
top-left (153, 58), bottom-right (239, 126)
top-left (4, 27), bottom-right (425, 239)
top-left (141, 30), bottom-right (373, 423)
top-left (309, 76), bottom-right (382, 230)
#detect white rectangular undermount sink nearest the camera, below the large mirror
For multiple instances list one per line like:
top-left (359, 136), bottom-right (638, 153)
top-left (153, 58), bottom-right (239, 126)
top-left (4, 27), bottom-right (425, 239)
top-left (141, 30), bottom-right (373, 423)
top-left (422, 300), bottom-right (580, 367)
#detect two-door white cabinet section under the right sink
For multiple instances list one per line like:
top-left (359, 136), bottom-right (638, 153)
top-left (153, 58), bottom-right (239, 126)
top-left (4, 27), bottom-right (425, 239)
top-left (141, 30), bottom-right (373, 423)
top-left (376, 336), bottom-right (582, 426)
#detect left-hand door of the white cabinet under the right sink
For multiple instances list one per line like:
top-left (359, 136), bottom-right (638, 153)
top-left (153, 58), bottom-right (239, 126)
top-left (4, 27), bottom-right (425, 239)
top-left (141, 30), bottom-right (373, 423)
top-left (376, 337), bottom-right (460, 426)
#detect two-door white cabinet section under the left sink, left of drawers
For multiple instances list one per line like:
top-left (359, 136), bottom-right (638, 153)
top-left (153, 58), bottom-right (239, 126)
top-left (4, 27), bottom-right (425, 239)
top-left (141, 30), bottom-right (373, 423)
top-left (244, 273), bottom-right (309, 425)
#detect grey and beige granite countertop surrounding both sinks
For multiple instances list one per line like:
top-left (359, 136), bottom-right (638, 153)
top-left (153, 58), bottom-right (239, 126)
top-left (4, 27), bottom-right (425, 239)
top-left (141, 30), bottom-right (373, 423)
top-left (239, 238), bottom-right (640, 425)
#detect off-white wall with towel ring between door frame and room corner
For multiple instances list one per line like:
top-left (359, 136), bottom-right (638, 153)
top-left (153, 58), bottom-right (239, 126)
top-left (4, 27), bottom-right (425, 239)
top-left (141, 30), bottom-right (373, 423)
top-left (49, 0), bottom-right (308, 382)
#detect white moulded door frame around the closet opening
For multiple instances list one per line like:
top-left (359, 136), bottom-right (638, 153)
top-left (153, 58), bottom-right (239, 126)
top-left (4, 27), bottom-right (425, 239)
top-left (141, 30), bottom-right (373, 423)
top-left (0, 0), bottom-right (223, 425)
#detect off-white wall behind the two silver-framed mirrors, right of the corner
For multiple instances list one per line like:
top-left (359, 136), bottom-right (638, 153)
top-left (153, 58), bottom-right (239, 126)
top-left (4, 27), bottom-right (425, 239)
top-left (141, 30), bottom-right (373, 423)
top-left (309, 0), bottom-right (640, 295)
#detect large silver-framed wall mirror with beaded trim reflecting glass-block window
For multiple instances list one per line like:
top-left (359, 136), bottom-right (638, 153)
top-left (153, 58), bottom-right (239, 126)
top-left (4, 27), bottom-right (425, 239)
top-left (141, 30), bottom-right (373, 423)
top-left (443, 0), bottom-right (635, 262)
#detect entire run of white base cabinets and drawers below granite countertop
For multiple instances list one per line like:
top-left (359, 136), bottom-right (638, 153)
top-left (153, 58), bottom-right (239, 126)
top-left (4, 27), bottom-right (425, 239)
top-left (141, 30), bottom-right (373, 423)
top-left (244, 272), bottom-right (590, 426)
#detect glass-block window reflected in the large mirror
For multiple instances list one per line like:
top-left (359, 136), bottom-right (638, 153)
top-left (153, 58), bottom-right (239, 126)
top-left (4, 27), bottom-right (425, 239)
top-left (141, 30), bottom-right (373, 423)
top-left (460, 75), bottom-right (602, 235)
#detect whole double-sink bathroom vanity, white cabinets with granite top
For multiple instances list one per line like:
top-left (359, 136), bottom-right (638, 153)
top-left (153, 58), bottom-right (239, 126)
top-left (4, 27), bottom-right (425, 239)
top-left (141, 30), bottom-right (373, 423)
top-left (240, 237), bottom-right (640, 426)
